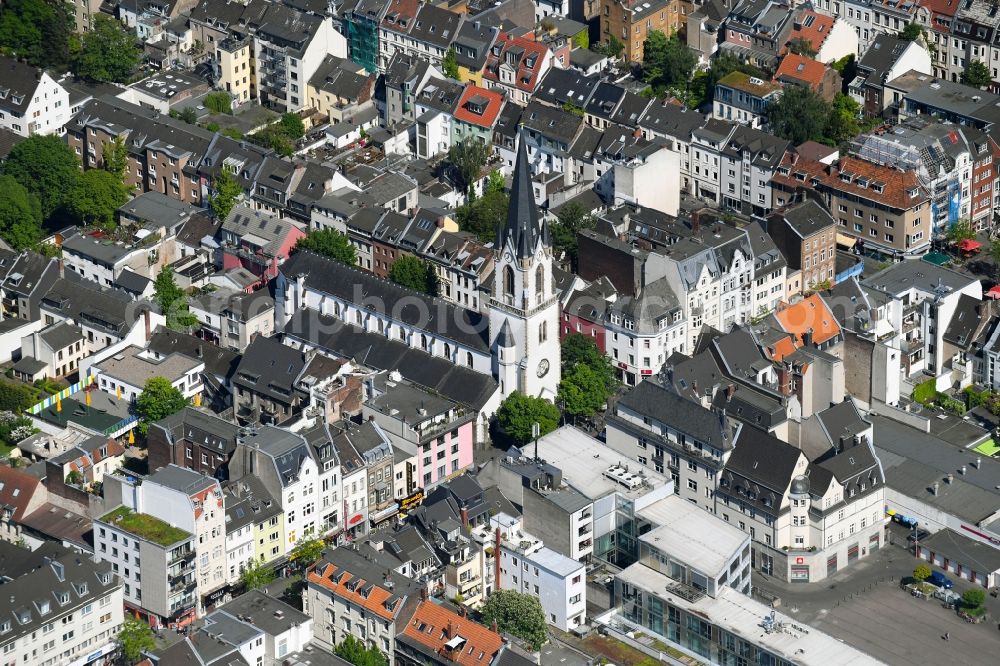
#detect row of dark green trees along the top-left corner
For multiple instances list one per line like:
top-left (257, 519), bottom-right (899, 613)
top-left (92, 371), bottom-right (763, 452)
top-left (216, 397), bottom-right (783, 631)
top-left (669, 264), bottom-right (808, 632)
top-left (0, 0), bottom-right (142, 83)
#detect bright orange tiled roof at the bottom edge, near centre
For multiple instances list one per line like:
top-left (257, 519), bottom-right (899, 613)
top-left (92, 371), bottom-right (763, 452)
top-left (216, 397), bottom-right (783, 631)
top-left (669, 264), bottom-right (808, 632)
top-left (403, 601), bottom-right (503, 666)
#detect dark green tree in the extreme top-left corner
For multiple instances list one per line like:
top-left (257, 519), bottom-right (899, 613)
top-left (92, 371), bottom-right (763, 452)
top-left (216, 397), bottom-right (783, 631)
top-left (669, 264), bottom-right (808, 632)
top-left (0, 0), bottom-right (75, 72)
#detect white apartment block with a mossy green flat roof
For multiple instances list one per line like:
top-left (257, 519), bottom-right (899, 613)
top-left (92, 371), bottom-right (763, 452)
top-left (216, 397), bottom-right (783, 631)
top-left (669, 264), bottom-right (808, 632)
top-left (94, 506), bottom-right (198, 628)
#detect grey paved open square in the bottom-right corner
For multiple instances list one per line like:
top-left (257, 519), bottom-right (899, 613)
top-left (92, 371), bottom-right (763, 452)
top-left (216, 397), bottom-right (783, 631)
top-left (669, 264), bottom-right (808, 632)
top-left (754, 546), bottom-right (1000, 666)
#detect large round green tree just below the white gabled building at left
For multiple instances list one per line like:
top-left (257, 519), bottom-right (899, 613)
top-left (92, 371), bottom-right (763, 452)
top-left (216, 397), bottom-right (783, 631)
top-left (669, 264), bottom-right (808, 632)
top-left (3, 134), bottom-right (80, 219)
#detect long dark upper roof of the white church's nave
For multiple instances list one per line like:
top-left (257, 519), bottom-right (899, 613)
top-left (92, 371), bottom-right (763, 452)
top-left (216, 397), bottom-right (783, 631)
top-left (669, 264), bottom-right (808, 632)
top-left (280, 249), bottom-right (490, 352)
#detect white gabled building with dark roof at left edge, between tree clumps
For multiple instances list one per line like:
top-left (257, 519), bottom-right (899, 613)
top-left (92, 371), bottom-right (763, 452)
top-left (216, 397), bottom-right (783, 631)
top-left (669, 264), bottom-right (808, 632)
top-left (0, 56), bottom-right (70, 137)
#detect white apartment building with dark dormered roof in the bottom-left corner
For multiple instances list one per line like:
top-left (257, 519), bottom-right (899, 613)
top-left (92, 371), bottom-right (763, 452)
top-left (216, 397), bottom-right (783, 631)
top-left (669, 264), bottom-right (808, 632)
top-left (0, 541), bottom-right (124, 666)
